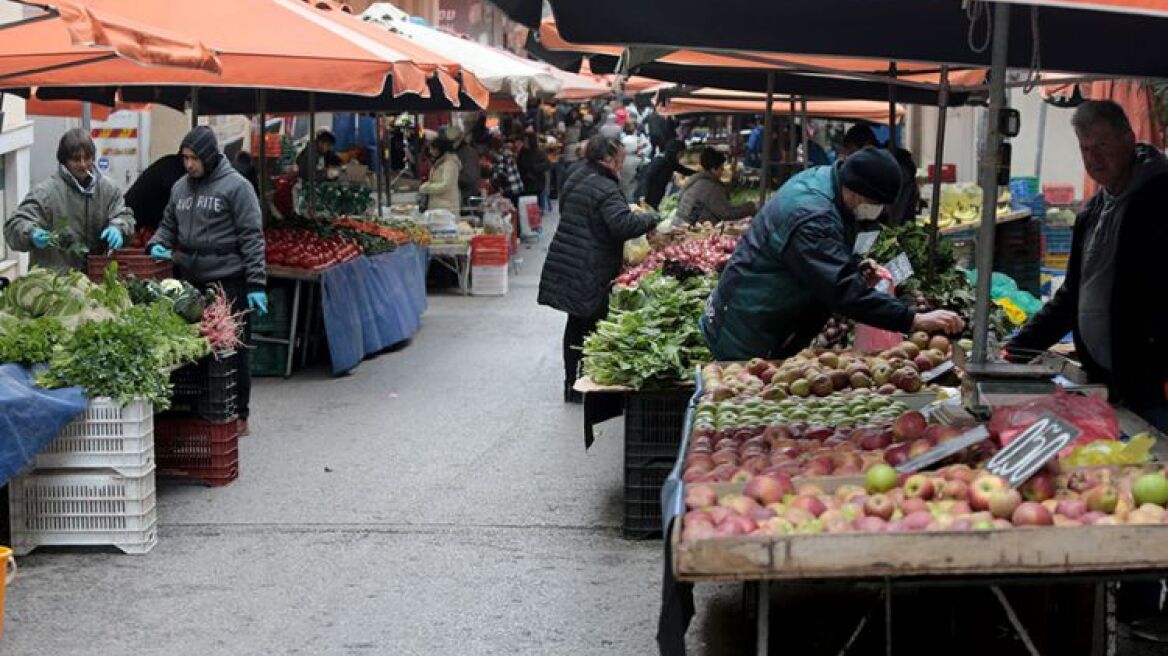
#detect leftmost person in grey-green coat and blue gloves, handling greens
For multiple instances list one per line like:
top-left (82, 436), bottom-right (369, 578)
top-left (4, 128), bottom-right (134, 271)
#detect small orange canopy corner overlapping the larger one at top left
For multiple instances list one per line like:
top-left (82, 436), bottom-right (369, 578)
top-left (0, 0), bottom-right (221, 86)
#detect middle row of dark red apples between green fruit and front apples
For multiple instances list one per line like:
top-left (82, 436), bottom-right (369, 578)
top-left (682, 411), bottom-right (996, 483)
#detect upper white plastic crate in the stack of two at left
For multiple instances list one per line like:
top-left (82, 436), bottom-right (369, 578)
top-left (33, 398), bottom-right (154, 476)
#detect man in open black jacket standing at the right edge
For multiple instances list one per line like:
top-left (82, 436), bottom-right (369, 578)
top-left (1007, 100), bottom-right (1168, 431)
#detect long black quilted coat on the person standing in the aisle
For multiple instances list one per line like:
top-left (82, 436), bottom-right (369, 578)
top-left (538, 162), bottom-right (658, 316)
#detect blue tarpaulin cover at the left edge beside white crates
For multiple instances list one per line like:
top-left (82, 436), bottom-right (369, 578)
top-left (0, 364), bottom-right (89, 484)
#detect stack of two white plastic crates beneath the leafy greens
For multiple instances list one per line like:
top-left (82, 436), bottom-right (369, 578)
top-left (8, 398), bottom-right (158, 556)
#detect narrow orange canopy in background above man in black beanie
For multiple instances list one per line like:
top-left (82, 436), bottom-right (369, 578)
top-left (659, 89), bottom-right (904, 124)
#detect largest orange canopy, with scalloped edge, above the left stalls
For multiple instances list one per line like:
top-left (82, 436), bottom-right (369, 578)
top-left (6, 0), bottom-right (489, 106)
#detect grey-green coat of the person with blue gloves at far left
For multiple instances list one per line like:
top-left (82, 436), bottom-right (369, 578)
top-left (4, 166), bottom-right (134, 271)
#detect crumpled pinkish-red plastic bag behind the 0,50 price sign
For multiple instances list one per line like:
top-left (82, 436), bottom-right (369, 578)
top-left (989, 390), bottom-right (1120, 458)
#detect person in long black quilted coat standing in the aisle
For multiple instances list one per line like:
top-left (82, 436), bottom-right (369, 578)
top-left (538, 134), bottom-right (658, 402)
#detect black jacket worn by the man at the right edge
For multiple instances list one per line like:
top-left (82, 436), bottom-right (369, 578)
top-left (1007, 145), bottom-right (1168, 412)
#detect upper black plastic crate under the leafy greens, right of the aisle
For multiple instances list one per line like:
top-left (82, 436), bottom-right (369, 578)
top-left (625, 390), bottom-right (694, 468)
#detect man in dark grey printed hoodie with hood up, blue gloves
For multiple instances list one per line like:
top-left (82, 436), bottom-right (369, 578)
top-left (146, 126), bottom-right (267, 434)
